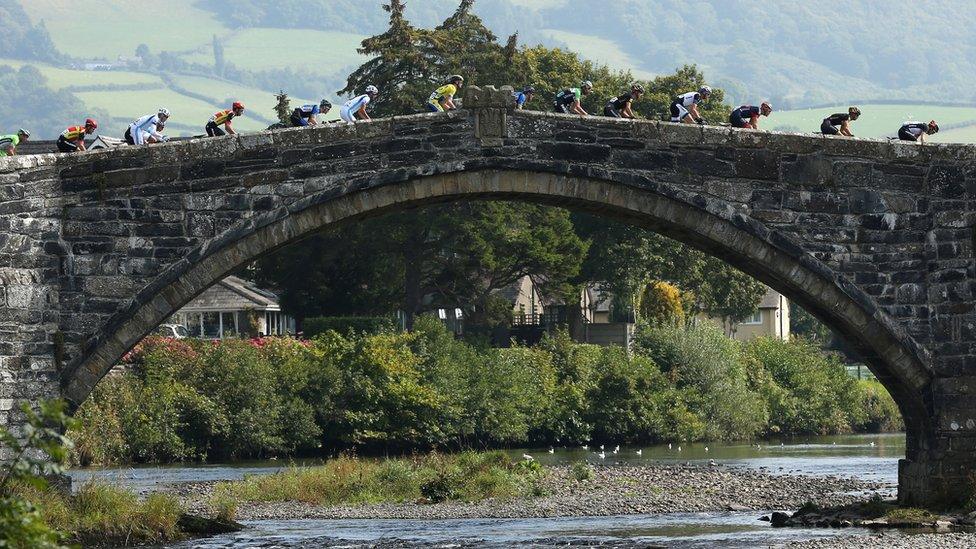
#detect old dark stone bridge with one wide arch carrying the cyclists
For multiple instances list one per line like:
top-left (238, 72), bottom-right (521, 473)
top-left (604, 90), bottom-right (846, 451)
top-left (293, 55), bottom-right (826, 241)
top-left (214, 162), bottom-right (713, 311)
top-left (0, 87), bottom-right (976, 503)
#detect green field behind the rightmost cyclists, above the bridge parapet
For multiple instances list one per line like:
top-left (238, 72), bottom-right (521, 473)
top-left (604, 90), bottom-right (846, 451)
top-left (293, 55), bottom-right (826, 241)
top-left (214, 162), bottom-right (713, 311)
top-left (772, 104), bottom-right (976, 143)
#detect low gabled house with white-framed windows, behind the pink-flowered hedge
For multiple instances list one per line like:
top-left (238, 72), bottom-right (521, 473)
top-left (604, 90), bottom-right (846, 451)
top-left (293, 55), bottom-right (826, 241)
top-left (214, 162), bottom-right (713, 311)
top-left (165, 276), bottom-right (295, 339)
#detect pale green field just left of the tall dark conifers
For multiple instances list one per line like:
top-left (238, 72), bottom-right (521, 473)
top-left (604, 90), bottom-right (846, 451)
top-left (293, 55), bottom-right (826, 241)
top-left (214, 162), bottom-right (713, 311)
top-left (177, 29), bottom-right (365, 74)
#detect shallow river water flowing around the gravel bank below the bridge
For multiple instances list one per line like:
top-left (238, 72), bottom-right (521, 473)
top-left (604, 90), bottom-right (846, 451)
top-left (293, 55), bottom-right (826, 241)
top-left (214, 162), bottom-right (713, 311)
top-left (70, 434), bottom-right (905, 549)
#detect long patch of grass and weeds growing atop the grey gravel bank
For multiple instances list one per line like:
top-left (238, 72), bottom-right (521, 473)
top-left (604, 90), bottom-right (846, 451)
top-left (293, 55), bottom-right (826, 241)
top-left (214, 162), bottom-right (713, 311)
top-left (211, 452), bottom-right (544, 507)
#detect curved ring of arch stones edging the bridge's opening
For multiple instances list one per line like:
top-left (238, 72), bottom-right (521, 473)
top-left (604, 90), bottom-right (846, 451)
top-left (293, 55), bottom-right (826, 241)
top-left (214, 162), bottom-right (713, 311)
top-left (61, 165), bottom-right (934, 466)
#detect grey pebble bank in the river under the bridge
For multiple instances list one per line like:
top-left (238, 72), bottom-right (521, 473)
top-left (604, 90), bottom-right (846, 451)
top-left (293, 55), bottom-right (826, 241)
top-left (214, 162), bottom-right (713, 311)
top-left (172, 465), bottom-right (888, 520)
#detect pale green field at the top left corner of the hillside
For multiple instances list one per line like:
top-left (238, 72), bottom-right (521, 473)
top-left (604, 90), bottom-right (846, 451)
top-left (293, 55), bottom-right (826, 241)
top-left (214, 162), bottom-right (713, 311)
top-left (20, 0), bottom-right (227, 61)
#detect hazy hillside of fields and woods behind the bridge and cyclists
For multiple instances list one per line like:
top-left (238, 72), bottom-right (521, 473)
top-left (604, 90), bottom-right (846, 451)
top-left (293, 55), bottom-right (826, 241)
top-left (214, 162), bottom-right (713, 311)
top-left (0, 0), bottom-right (976, 140)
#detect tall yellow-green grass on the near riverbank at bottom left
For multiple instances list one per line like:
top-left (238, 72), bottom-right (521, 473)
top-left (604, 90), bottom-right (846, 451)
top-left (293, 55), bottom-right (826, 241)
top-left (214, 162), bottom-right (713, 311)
top-left (21, 482), bottom-right (183, 546)
